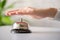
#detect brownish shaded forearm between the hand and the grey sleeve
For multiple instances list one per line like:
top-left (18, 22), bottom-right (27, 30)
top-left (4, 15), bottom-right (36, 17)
top-left (37, 8), bottom-right (57, 17)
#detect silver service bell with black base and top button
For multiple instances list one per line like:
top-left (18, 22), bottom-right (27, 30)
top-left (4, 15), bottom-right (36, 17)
top-left (12, 18), bottom-right (31, 33)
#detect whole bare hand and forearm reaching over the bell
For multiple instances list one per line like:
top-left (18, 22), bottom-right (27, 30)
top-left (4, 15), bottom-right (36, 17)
top-left (6, 7), bottom-right (58, 19)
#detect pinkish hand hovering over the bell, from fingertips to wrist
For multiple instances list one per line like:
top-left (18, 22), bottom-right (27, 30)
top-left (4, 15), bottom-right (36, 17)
top-left (6, 7), bottom-right (40, 18)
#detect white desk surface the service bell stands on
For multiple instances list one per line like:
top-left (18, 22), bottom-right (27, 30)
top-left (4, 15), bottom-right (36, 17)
top-left (0, 26), bottom-right (60, 40)
